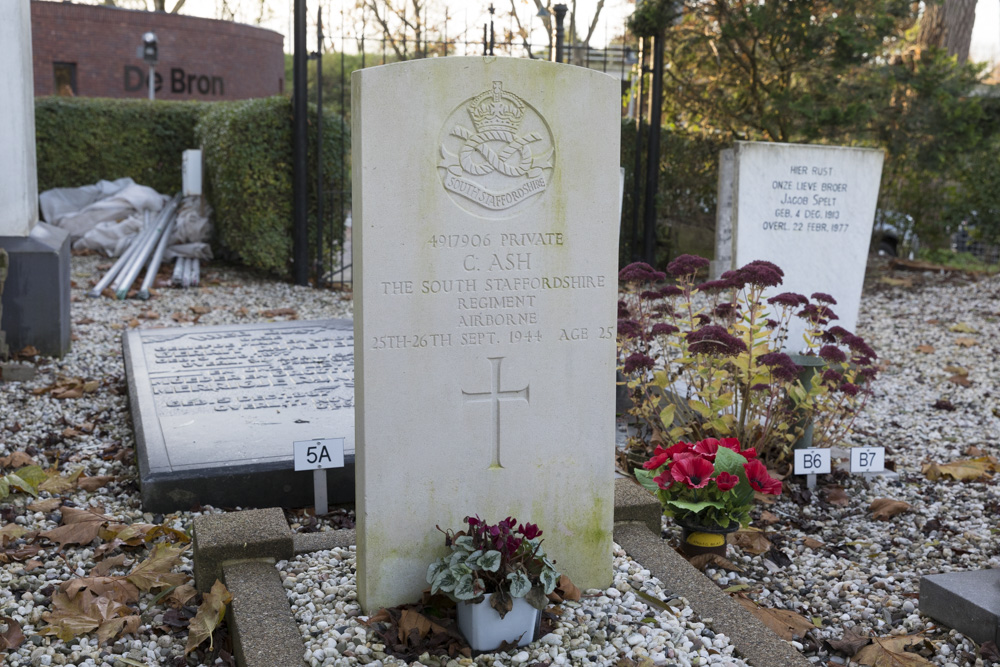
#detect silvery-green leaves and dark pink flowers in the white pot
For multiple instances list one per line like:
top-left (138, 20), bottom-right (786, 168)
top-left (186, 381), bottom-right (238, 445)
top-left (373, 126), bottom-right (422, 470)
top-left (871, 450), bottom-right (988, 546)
top-left (427, 516), bottom-right (560, 618)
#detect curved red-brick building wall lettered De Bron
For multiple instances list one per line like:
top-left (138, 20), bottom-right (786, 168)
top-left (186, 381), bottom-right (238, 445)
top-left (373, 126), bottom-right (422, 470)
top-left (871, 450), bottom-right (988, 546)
top-left (32, 0), bottom-right (285, 101)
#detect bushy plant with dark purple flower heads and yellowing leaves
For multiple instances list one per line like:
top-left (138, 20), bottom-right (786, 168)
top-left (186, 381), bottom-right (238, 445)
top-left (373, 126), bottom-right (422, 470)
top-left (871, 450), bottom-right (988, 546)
top-left (618, 255), bottom-right (877, 466)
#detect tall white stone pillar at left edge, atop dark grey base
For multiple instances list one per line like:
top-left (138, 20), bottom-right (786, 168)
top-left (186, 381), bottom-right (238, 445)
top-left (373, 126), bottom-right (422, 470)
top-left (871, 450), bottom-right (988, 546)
top-left (0, 0), bottom-right (38, 236)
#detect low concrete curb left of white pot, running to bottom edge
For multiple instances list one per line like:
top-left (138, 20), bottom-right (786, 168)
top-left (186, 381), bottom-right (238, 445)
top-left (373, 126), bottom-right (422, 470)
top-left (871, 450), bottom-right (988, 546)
top-left (223, 561), bottom-right (306, 667)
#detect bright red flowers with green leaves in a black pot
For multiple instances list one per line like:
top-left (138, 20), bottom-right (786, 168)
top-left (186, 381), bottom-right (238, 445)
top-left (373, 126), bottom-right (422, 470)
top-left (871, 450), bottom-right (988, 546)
top-left (636, 438), bottom-right (781, 556)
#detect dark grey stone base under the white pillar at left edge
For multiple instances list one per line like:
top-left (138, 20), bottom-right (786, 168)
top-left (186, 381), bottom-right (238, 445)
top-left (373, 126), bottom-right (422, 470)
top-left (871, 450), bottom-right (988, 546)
top-left (0, 222), bottom-right (70, 357)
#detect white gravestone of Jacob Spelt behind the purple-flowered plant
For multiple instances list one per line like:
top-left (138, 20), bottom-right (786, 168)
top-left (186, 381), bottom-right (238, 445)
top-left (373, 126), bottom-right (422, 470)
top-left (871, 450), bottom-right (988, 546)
top-left (719, 142), bottom-right (883, 351)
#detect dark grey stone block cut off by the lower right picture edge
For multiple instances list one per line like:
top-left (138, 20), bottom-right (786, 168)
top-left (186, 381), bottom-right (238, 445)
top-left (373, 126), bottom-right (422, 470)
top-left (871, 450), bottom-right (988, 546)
top-left (920, 570), bottom-right (1000, 644)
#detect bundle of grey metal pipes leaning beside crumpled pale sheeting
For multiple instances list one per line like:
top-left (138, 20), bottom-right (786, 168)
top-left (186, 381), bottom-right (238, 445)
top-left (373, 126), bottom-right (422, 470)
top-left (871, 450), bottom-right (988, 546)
top-left (87, 193), bottom-right (181, 299)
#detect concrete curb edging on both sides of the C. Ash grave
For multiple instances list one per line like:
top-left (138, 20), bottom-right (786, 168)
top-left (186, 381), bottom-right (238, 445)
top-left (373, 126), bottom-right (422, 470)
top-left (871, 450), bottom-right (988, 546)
top-left (194, 478), bottom-right (812, 667)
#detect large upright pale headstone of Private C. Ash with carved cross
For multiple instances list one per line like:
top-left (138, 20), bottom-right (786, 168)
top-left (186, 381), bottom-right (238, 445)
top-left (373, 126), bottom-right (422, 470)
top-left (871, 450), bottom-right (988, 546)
top-left (352, 57), bottom-right (620, 611)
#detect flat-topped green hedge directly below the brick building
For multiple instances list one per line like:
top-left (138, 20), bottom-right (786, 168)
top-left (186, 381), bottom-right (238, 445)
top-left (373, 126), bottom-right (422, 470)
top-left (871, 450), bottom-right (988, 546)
top-left (35, 97), bottom-right (206, 194)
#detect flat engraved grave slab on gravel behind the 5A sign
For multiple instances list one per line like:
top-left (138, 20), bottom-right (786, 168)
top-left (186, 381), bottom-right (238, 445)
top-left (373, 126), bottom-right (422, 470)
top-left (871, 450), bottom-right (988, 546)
top-left (124, 320), bottom-right (354, 512)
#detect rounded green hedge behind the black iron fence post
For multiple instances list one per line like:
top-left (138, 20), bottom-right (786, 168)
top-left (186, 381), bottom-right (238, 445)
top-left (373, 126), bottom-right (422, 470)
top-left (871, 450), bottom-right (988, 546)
top-left (195, 97), bottom-right (350, 276)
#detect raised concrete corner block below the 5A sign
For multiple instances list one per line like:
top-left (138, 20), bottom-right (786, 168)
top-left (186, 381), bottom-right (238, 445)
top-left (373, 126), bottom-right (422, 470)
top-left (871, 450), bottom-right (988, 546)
top-left (194, 507), bottom-right (295, 592)
